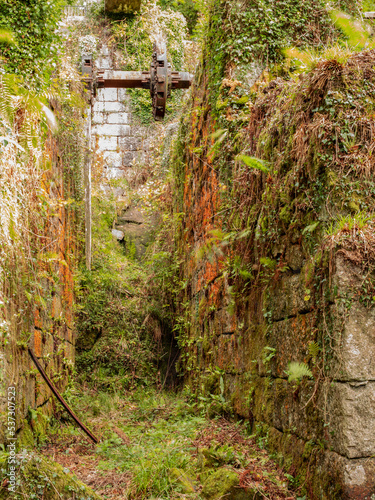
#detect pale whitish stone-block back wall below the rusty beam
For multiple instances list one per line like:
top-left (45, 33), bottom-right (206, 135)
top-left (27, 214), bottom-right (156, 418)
top-left (92, 45), bottom-right (162, 258)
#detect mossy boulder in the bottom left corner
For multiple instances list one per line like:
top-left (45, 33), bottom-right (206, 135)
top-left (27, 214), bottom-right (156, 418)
top-left (0, 452), bottom-right (102, 500)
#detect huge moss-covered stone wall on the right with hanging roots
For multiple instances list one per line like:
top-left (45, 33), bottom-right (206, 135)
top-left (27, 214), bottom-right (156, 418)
top-left (173, 1), bottom-right (375, 499)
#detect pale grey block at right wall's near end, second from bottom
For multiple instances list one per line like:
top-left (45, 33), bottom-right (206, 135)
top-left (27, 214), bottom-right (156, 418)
top-left (329, 381), bottom-right (375, 458)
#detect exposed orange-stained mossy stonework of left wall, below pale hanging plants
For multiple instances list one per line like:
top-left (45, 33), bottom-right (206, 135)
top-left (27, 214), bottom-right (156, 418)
top-left (0, 99), bottom-right (85, 446)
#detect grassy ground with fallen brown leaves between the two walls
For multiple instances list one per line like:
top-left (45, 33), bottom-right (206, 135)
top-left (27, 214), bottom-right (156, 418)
top-left (36, 388), bottom-right (295, 500)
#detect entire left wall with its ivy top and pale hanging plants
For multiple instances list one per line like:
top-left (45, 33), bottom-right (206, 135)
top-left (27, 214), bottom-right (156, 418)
top-left (0, 1), bottom-right (86, 458)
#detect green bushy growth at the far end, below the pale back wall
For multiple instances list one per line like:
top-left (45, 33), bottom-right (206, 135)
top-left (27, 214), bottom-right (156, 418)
top-left (76, 195), bottom-right (162, 391)
